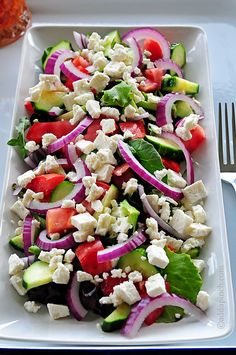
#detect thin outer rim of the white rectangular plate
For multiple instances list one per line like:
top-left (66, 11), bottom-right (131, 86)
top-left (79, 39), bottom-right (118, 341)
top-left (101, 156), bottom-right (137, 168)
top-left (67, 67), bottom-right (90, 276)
top-left (0, 22), bottom-right (235, 349)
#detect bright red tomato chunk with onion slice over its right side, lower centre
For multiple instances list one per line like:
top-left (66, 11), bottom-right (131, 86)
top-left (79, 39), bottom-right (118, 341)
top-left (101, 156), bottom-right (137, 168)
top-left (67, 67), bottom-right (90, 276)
top-left (75, 238), bottom-right (112, 276)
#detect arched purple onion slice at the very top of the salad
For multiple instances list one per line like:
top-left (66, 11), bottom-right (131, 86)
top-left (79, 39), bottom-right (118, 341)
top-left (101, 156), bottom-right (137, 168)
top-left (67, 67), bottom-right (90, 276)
top-left (122, 27), bottom-right (170, 59)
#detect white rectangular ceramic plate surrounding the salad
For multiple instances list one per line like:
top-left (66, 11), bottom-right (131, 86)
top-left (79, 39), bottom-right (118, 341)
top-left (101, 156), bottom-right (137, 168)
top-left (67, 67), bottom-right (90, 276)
top-left (0, 25), bottom-right (234, 347)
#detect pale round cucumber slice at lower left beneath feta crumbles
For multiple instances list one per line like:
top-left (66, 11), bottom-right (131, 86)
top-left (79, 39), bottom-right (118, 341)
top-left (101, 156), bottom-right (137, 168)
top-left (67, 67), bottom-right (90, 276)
top-left (23, 261), bottom-right (54, 290)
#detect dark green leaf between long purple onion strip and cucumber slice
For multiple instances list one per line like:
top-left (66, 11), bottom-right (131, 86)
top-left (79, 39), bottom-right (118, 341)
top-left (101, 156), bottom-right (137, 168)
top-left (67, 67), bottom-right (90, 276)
top-left (129, 139), bottom-right (164, 174)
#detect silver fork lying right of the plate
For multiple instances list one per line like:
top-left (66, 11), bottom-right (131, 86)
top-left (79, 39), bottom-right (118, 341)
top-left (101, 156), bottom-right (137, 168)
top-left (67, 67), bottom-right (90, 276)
top-left (218, 103), bottom-right (236, 192)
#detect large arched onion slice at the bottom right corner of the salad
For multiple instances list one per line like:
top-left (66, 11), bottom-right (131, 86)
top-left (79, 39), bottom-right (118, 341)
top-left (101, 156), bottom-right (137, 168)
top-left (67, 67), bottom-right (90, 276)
top-left (121, 293), bottom-right (209, 338)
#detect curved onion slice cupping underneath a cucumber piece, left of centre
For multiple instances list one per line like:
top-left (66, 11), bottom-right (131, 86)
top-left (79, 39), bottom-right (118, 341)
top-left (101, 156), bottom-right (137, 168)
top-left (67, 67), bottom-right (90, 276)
top-left (28, 183), bottom-right (85, 214)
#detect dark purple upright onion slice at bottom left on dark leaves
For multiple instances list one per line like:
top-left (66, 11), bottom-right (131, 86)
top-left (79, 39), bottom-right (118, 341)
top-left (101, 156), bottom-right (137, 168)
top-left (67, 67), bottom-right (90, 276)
top-left (66, 272), bottom-right (88, 320)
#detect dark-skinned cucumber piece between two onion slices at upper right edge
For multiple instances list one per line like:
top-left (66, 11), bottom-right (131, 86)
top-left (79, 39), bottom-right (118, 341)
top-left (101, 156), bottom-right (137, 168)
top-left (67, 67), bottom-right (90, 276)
top-left (161, 74), bottom-right (199, 95)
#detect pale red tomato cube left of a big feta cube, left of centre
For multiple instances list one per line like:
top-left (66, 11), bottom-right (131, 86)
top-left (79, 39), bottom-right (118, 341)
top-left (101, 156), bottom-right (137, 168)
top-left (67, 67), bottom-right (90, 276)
top-left (46, 207), bottom-right (77, 234)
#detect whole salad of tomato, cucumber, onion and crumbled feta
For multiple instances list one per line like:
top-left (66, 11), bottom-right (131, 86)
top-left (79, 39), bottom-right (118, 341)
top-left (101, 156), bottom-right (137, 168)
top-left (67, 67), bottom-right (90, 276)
top-left (8, 28), bottom-right (211, 337)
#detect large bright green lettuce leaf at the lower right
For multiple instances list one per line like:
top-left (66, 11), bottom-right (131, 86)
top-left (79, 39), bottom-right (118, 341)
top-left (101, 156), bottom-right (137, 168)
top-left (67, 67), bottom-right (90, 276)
top-left (163, 248), bottom-right (202, 303)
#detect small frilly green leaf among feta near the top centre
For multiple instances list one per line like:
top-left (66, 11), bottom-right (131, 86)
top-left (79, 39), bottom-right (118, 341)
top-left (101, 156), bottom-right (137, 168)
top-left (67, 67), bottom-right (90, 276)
top-left (102, 81), bottom-right (133, 107)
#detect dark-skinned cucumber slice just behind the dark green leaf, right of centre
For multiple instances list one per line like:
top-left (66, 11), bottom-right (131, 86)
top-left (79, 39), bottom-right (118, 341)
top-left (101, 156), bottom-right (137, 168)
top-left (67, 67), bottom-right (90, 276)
top-left (146, 135), bottom-right (184, 161)
